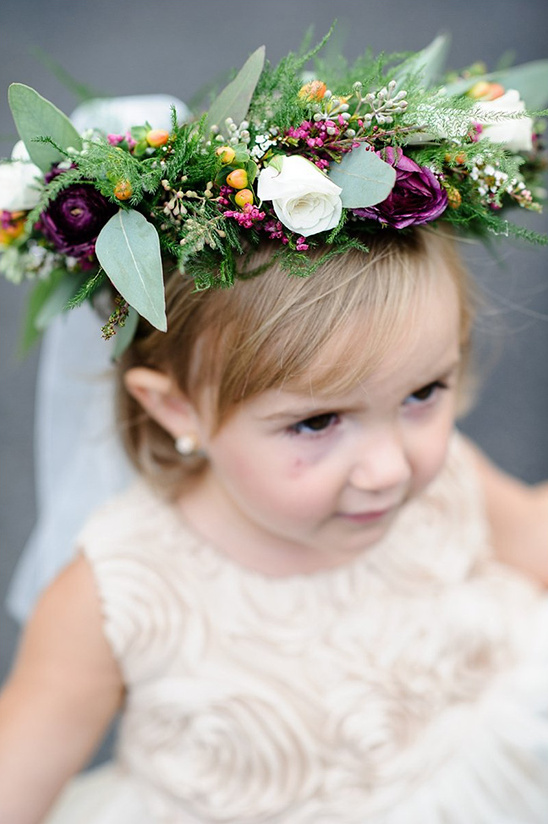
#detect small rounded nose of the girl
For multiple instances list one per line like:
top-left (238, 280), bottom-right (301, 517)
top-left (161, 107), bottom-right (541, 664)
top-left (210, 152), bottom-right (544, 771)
top-left (350, 430), bottom-right (411, 492)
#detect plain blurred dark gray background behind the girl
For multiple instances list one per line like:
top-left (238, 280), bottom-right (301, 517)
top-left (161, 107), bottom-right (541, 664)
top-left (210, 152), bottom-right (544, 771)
top-left (0, 0), bottom-right (548, 680)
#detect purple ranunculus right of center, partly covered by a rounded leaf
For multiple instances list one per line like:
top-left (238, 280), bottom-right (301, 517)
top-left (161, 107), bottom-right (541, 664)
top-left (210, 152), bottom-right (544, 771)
top-left (353, 146), bottom-right (447, 229)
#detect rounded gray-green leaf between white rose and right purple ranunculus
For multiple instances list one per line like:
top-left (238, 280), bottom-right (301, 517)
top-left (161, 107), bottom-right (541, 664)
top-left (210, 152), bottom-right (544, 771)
top-left (329, 145), bottom-right (396, 209)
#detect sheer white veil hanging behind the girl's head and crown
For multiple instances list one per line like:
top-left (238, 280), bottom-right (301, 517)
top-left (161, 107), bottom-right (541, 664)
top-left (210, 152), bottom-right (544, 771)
top-left (6, 95), bottom-right (188, 621)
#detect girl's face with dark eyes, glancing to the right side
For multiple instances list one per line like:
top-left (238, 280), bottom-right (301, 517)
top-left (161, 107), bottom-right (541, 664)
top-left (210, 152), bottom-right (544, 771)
top-left (181, 272), bottom-right (460, 575)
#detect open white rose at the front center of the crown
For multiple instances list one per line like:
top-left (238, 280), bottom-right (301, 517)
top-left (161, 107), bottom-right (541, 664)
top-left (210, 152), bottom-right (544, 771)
top-left (257, 155), bottom-right (342, 237)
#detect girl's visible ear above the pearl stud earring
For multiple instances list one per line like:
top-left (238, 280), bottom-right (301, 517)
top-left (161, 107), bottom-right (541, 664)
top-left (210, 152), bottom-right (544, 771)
top-left (124, 366), bottom-right (197, 438)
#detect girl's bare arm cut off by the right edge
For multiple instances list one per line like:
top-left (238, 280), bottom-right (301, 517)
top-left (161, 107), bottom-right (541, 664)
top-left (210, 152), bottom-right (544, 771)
top-left (460, 440), bottom-right (548, 587)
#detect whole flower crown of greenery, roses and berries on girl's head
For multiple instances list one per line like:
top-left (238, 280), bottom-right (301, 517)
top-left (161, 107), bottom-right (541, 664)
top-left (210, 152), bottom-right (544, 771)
top-left (0, 36), bottom-right (548, 349)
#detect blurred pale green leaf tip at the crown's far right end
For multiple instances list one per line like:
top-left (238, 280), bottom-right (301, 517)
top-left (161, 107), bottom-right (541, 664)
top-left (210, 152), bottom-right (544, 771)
top-left (445, 60), bottom-right (548, 112)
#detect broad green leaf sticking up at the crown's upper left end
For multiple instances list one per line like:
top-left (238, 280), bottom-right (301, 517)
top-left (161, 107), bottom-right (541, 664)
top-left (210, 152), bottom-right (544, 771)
top-left (8, 83), bottom-right (82, 172)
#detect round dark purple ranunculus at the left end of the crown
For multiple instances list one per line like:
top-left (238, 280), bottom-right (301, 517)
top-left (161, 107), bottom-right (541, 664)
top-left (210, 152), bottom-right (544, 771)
top-left (39, 177), bottom-right (116, 258)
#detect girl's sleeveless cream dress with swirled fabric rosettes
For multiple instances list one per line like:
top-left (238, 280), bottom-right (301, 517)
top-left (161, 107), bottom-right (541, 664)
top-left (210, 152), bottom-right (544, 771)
top-left (44, 435), bottom-right (548, 824)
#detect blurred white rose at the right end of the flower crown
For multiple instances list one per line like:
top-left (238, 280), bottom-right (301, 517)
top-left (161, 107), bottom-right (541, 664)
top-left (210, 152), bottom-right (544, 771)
top-left (474, 89), bottom-right (533, 152)
